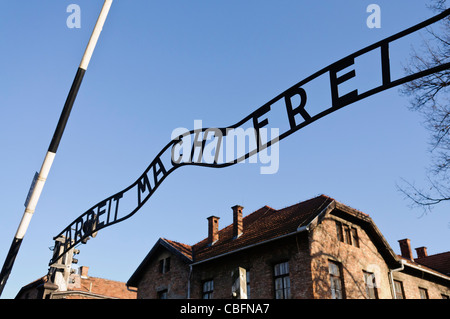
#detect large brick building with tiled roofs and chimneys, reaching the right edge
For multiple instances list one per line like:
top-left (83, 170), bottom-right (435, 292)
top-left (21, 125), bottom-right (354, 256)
top-left (127, 195), bottom-right (450, 299)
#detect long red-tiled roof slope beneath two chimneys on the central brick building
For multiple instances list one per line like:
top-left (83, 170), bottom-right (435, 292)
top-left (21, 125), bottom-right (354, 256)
top-left (164, 195), bottom-right (333, 262)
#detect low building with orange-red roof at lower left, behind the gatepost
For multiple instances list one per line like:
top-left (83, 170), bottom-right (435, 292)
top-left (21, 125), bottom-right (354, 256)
top-left (15, 266), bottom-right (137, 299)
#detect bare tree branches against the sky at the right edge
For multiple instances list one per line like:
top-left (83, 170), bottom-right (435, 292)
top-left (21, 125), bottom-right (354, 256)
top-left (397, 0), bottom-right (450, 212)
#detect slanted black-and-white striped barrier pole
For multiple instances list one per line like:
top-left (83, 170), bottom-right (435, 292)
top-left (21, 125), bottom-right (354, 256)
top-left (0, 0), bottom-right (113, 295)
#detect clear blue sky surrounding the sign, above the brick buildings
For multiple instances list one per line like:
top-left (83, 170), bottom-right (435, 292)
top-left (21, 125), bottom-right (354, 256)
top-left (0, 0), bottom-right (450, 298)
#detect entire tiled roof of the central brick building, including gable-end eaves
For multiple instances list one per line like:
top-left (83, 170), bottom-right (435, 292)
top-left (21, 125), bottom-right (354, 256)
top-left (128, 195), bottom-right (412, 286)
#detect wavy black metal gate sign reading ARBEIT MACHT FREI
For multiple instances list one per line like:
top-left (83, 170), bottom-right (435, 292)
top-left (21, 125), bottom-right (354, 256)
top-left (50, 10), bottom-right (450, 264)
